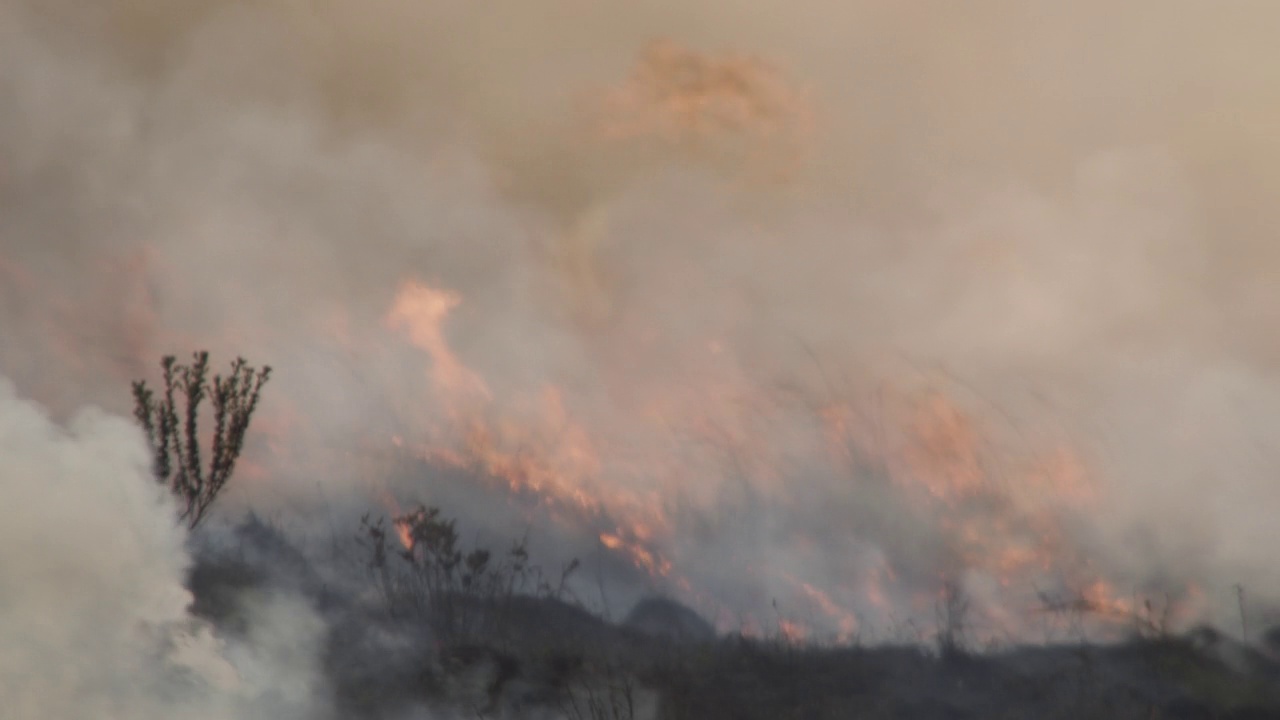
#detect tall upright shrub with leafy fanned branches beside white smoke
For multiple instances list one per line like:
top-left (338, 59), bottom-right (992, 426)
top-left (133, 351), bottom-right (271, 528)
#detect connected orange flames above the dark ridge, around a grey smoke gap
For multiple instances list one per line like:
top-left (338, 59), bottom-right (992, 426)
top-left (363, 270), bottom-right (1198, 639)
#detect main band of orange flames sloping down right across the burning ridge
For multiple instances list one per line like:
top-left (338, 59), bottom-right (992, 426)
top-left (366, 275), bottom-right (1182, 641)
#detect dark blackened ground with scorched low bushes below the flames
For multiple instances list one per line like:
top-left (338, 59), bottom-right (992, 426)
top-left (175, 507), bottom-right (1280, 720)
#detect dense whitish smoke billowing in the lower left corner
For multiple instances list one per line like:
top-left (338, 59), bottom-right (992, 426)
top-left (0, 378), bottom-right (324, 720)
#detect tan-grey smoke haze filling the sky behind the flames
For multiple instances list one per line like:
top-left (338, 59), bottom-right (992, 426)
top-left (0, 0), bottom-right (1280, 638)
